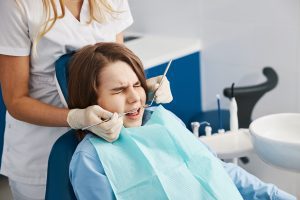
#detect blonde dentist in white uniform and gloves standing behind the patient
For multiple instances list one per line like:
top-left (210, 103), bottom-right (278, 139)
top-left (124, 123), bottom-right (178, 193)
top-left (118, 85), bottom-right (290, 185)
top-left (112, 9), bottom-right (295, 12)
top-left (0, 0), bottom-right (172, 200)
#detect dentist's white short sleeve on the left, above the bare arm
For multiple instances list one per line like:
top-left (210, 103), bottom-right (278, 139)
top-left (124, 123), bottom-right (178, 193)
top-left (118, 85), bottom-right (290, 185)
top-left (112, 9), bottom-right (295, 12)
top-left (0, 0), bottom-right (31, 56)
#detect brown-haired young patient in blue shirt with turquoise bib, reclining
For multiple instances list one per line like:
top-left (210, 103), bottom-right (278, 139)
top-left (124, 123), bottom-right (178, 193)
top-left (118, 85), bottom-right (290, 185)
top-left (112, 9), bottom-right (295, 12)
top-left (69, 43), bottom-right (295, 200)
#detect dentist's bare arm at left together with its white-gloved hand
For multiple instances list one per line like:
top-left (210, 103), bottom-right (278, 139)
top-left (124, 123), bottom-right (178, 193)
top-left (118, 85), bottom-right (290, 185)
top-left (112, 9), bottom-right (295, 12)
top-left (0, 55), bottom-right (123, 142)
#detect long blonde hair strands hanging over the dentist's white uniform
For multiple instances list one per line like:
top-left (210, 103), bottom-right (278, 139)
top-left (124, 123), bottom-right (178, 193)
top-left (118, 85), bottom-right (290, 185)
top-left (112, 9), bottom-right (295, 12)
top-left (31, 0), bottom-right (118, 52)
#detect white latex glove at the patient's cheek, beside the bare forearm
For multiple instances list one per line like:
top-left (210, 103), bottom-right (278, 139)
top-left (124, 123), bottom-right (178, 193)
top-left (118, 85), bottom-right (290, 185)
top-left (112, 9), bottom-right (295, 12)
top-left (67, 105), bottom-right (123, 142)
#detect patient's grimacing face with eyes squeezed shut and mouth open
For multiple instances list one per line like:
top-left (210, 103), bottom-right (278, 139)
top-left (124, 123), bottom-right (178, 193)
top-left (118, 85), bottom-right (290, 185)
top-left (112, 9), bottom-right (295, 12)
top-left (97, 61), bottom-right (146, 127)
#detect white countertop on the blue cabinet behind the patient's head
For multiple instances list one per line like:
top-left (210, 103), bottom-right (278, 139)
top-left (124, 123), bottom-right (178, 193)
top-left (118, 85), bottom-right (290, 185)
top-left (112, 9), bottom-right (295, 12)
top-left (126, 35), bottom-right (201, 69)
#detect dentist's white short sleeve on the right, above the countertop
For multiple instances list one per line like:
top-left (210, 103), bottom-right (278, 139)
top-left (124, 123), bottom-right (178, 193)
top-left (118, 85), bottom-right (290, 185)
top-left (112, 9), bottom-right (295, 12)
top-left (111, 0), bottom-right (133, 34)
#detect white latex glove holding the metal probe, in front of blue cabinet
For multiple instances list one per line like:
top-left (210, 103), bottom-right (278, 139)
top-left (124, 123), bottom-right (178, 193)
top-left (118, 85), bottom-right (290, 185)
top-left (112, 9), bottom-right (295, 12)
top-left (147, 75), bottom-right (173, 103)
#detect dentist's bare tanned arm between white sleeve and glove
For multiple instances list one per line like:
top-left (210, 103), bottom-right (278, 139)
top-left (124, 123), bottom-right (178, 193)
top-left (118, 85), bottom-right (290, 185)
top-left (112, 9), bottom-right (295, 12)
top-left (0, 55), bottom-right (69, 126)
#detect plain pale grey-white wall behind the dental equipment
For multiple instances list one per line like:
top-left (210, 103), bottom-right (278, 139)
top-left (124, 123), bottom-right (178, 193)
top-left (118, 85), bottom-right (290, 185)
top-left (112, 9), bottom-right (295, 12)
top-left (130, 0), bottom-right (300, 118)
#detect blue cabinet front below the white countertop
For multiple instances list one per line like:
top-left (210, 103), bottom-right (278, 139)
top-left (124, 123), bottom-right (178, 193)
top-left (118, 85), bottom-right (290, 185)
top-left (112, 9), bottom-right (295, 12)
top-left (146, 52), bottom-right (202, 128)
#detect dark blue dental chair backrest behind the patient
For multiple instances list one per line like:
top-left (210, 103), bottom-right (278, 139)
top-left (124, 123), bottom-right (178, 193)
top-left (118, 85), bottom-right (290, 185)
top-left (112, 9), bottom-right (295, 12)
top-left (45, 53), bottom-right (79, 200)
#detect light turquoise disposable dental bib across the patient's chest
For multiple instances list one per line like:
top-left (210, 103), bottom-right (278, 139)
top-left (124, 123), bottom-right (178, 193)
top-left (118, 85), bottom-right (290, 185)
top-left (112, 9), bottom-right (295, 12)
top-left (90, 106), bottom-right (242, 200)
